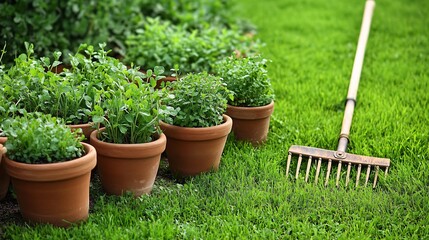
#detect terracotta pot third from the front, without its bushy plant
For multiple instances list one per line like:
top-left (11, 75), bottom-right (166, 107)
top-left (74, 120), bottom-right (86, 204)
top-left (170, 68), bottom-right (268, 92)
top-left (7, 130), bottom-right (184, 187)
top-left (161, 115), bottom-right (232, 177)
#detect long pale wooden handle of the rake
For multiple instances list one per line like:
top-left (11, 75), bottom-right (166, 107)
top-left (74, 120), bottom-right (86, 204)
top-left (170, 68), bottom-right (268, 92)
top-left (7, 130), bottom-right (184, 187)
top-left (337, 0), bottom-right (375, 154)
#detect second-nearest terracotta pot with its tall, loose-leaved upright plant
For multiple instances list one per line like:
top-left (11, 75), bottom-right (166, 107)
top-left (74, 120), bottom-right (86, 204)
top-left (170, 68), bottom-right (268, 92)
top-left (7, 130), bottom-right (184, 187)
top-left (90, 68), bottom-right (168, 196)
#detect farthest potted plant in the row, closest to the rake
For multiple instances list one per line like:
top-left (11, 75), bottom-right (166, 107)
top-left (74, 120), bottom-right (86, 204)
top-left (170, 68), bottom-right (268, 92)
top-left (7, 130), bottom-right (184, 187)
top-left (214, 56), bottom-right (274, 145)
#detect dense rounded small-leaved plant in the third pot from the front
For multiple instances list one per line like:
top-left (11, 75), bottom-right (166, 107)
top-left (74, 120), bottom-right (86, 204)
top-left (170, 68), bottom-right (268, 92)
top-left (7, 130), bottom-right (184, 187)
top-left (164, 72), bottom-right (233, 127)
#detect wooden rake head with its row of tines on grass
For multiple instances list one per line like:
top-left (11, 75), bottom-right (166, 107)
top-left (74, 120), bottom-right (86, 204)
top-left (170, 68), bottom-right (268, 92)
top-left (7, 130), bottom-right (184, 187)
top-left (286, 145), bottom-right (390, 188)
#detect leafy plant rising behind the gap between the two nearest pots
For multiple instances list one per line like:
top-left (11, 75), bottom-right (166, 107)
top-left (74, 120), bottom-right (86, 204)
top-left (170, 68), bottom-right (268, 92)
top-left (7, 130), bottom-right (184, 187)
top-left (60, 43), bottom-right (135, 124)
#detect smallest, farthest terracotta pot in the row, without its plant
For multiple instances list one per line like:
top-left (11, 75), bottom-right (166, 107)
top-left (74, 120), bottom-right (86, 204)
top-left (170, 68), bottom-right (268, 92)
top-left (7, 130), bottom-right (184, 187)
top-left (226, 101), bottom-right (274, 146)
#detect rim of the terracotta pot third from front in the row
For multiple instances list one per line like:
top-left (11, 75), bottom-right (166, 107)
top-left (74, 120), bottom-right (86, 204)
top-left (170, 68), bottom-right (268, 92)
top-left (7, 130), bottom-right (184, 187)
top-left (160, 114), bottom-right (233, 141)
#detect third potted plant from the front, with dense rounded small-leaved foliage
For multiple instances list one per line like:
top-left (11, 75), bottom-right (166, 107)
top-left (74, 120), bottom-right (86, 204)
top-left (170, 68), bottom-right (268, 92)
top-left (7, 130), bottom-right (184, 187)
top-left (161, 72), bottom-right (232, 176)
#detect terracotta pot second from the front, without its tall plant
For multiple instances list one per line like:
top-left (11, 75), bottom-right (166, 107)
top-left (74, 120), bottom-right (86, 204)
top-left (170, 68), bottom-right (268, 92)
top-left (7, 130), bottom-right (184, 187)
top-left (91, 128), bottom-right (166, 196)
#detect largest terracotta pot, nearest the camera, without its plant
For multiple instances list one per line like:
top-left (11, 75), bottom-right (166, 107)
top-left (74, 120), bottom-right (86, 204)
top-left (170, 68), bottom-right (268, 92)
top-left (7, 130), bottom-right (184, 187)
top-left (5, 143), bottom-right (97, 227)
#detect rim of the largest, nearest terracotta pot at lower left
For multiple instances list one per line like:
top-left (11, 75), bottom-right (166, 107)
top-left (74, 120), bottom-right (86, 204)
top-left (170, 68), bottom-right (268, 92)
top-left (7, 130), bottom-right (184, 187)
top-left (4, 142), bottom-right (97, 182)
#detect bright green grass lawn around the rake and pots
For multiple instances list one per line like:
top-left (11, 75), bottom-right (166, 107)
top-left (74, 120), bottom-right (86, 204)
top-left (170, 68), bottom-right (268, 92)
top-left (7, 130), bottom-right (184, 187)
top-left (1, 0), bottom-right (429, 240)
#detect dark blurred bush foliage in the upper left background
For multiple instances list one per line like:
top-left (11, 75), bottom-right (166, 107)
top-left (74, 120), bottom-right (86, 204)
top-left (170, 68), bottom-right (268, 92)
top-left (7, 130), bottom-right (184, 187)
top-left (0, 0), bottom-right (143, 65)
